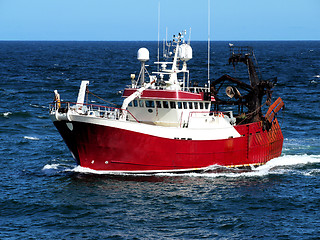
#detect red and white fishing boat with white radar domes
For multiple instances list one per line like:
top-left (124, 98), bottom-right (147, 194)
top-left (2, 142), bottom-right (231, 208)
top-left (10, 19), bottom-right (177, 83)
top-left (49, 32), bottom-right (284, 173)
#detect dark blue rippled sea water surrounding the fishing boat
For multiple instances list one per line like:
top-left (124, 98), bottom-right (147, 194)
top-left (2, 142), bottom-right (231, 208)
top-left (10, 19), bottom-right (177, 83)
top-left (0, 41), bottom-right (320, 239)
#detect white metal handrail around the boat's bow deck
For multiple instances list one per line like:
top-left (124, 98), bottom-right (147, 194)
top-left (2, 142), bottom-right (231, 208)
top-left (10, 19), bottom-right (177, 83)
top-left (49, 101), bottom-right (139, 123)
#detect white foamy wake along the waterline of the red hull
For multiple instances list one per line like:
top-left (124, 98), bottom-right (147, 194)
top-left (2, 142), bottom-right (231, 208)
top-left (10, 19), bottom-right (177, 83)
top-left (43, 154), bottom-right (320, 178)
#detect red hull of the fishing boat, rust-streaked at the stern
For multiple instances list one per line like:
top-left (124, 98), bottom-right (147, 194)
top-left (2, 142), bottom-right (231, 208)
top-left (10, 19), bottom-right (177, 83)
top-left (54, 119), bottom-right (283, 172)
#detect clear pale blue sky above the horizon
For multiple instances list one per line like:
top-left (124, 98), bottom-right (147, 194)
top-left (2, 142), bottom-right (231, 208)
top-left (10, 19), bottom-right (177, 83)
top-left (0, 0), bottom-right (320, 41)
